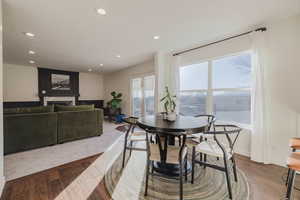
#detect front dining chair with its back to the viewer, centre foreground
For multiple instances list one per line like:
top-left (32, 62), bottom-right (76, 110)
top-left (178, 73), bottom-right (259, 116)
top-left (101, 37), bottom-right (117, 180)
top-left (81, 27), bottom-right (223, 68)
top-left (144, 130), bottom-right (187, 200)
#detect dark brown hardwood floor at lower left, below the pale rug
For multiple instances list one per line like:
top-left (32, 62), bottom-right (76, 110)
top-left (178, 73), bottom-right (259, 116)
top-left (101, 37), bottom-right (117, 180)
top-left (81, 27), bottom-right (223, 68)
top-left (1, 155), bottom-right (111, 200)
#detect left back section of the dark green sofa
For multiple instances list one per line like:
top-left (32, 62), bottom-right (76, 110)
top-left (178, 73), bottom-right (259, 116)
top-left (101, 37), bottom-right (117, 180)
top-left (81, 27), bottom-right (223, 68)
top-left (3, 112), bottom-right (57, 154)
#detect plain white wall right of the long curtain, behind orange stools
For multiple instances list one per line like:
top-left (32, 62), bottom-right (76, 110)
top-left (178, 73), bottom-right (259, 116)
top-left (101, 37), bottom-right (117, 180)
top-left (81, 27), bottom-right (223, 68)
top-left (266, 15), bottom-right (300, 165)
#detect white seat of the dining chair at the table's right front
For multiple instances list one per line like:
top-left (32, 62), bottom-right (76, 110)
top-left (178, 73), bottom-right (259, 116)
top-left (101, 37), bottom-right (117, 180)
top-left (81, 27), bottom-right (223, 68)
top-left (196, 141), bottom-right (232, 159)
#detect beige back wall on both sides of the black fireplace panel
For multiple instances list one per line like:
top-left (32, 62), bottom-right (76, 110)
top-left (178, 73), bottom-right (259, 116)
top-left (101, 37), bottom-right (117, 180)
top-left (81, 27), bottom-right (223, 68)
top-left (3, 63), bottom-right (104, 101)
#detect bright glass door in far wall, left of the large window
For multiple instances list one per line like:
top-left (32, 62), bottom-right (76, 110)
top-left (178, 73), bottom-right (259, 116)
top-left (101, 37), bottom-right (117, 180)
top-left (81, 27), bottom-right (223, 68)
top-left (131, 75), bottom-right (155, 117)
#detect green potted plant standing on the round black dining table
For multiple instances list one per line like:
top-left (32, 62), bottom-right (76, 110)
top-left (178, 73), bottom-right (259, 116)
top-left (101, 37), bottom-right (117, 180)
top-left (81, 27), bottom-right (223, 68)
top-left (160, 87), bottom-right (176, 121)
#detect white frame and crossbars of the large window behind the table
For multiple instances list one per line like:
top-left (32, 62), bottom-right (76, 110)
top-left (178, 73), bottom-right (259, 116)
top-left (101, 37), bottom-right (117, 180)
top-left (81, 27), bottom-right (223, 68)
top-left (179, 50), bottom-right (253, 129)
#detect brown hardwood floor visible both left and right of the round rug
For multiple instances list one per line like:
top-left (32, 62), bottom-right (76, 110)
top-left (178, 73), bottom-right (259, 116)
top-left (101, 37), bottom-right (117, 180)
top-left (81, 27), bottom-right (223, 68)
top-left (1, 155), bottom-right (300, 200)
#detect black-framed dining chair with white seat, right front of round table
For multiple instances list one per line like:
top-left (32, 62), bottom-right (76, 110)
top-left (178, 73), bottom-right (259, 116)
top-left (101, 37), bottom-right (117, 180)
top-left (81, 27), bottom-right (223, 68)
top-left (191, 125), bottom-right (242, 199)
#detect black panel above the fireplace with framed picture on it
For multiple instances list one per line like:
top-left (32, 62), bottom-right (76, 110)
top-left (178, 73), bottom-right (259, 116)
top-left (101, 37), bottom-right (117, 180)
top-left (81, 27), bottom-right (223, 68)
top-left (38, 68), bottom-right (79, 99)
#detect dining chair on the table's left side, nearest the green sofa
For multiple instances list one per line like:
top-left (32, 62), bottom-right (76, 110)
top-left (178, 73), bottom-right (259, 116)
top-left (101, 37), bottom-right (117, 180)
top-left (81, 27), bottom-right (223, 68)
top-left (122, 117), bottom-right (147, 168)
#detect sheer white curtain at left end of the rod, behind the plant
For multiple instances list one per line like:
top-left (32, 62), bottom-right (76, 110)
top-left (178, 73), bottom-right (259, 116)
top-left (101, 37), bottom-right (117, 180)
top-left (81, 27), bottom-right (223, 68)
top-left (168, 56), bottom-right (181, 114)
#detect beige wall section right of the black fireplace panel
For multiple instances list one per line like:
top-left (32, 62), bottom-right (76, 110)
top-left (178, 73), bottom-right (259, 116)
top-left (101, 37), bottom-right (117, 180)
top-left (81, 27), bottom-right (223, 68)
top-left (79, 73), bottom-right (104, 100)
